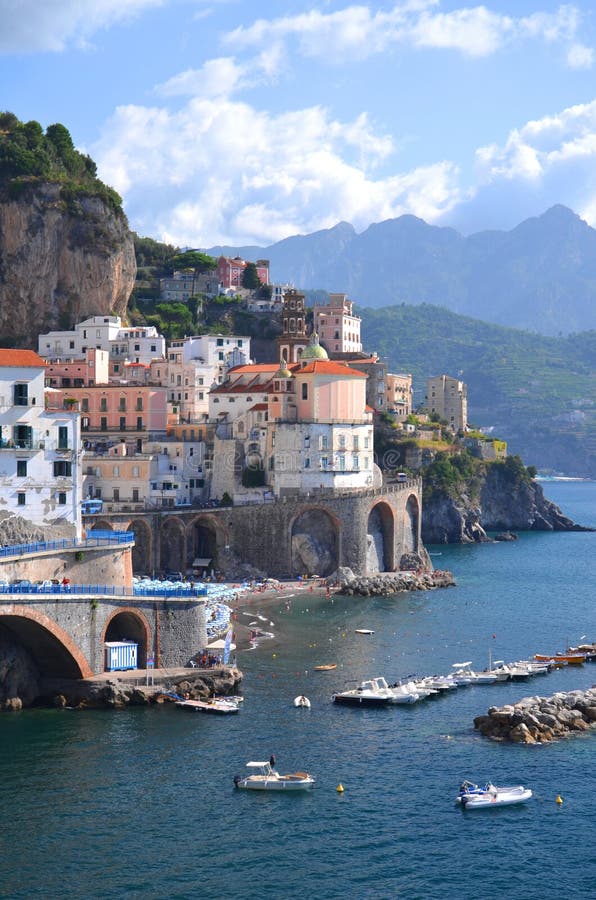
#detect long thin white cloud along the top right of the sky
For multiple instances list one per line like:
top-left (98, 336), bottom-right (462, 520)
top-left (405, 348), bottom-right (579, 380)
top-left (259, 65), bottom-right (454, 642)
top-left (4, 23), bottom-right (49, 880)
top-left (225, 0), bottom-right (590, 67)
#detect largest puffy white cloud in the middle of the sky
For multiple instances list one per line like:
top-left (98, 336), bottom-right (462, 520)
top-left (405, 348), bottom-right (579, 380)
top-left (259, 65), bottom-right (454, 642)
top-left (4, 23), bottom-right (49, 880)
top-left (92, 97), bottom-right (459, 247)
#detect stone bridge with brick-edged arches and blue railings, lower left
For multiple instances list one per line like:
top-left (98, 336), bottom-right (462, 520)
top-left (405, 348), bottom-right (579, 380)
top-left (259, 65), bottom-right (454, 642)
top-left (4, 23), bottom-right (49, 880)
top-left (0, 533), bottom-right (207, 695)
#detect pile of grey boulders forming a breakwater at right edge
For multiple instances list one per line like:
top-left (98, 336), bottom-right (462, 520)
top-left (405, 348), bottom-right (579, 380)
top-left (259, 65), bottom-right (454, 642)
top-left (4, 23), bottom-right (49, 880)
top-left (474, 687), bottom-right (596, 744)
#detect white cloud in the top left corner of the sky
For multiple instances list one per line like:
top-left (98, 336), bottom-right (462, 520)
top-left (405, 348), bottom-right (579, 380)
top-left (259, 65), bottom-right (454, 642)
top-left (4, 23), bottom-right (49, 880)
top-left (0, 0), bottom-right (166, 53)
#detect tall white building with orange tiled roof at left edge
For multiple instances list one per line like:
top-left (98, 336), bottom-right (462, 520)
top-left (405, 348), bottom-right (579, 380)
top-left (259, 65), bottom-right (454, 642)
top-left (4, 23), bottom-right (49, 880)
top-left (0, 349), bottom-right (83, 539)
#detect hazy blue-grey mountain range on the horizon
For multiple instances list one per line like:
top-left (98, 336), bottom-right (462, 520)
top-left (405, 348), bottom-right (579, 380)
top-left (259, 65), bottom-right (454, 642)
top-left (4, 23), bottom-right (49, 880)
top-left (206, 205), bottom-right (596, 335)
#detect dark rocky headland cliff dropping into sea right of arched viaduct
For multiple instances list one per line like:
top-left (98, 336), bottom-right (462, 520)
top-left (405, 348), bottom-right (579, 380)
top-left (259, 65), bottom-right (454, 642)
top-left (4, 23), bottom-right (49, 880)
top-left (422, 474), bottom-right (591, 544)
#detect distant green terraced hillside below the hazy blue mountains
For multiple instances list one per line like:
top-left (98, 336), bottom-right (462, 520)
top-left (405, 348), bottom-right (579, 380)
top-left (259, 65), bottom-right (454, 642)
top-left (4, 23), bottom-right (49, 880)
top-left (357, 304), bottom-right (596, 476)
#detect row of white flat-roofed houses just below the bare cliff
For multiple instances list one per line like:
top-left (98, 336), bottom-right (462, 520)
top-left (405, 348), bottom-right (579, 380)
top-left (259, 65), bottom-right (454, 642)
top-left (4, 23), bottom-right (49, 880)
top-left (38, 316), bottom-right (166, 363)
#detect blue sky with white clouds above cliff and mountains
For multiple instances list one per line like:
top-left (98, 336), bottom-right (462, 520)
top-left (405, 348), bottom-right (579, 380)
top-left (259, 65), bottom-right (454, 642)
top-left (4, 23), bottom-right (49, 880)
top-left (0, 0), bottom-right (596, 248)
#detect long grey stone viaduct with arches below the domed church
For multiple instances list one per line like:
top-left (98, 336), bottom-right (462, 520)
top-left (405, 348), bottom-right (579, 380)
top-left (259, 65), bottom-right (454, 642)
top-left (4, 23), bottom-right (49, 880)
top-left (85, 480), bottom-right (422, 577)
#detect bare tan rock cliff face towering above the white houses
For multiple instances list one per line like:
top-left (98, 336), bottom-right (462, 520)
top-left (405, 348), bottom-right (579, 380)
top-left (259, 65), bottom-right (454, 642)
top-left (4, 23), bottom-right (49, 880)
top-left (0, 183), bottom-right (136, 349)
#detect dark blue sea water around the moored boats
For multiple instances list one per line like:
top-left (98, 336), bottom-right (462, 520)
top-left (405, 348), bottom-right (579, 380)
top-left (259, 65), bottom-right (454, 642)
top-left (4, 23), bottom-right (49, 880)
top-left (0, 482), bottom-right (596, 900)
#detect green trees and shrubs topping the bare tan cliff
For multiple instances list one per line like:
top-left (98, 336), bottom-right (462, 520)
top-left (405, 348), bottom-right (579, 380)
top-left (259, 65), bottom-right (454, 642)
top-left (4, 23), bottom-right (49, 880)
top-left (0, 112), bottom-right (124, 215)
